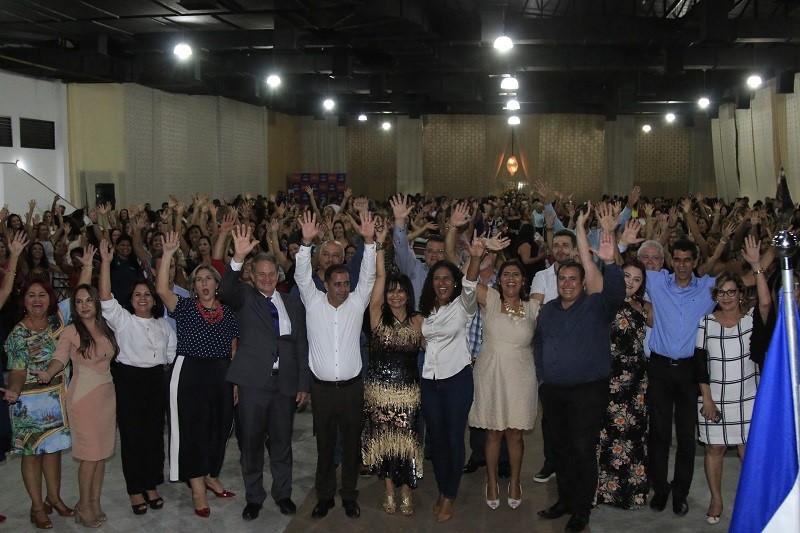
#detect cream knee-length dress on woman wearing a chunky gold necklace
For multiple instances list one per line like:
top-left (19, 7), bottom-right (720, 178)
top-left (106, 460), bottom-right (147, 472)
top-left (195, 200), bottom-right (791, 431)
top-left (469, 289), bottom-right (540, 431)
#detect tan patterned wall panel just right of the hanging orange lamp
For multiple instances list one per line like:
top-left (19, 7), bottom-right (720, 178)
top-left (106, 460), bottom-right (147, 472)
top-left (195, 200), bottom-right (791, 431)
top-left (537, 115), bottom-right (606, 200)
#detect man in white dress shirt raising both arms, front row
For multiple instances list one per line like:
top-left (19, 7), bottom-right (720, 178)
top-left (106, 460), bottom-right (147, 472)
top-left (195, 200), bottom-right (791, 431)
top-left (294, 211), bottom-right (376, 518)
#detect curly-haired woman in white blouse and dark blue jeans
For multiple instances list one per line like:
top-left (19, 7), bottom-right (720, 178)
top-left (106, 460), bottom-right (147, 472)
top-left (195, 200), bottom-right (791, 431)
top-left (419, 232), bottom-right (499, 522)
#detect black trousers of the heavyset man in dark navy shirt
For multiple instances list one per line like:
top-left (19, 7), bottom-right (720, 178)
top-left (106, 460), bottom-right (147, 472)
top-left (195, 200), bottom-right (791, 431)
top-left (539, 380), bottom-right (608, 516)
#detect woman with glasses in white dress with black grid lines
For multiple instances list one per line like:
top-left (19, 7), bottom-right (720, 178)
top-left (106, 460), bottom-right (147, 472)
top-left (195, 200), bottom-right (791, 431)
top-left (695, 236), bottom-right (772, 524)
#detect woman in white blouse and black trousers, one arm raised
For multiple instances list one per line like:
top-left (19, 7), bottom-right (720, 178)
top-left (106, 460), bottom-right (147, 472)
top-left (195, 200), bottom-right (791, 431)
top-left (99, 240), bottom-right (178, 515)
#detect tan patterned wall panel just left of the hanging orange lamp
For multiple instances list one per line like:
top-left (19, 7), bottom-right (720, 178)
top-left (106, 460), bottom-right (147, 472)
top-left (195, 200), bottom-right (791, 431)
top-left (422, 115), bottom-right (484, 196)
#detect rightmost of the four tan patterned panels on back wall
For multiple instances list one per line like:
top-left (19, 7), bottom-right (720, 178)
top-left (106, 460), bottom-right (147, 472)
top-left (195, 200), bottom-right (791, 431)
top-left (634, 118), bottom-right (695, 197)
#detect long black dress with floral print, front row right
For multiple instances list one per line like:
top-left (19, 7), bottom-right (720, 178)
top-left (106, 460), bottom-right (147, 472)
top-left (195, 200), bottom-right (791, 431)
top-left (596, 301), bottom-right (649, 509)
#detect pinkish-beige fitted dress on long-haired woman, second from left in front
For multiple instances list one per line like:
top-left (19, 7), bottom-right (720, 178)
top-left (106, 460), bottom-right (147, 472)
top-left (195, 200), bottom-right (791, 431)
top-left (53, 326), bottom-right (117, 461)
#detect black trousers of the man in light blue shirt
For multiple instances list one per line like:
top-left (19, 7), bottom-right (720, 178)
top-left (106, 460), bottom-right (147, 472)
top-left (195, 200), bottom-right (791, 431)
top-left (647, 352), bottom-right (699, 499)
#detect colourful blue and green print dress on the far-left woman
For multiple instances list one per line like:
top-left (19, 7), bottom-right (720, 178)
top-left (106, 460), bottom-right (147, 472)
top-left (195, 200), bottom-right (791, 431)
top-left (6, 317), bottom-right (72, 455)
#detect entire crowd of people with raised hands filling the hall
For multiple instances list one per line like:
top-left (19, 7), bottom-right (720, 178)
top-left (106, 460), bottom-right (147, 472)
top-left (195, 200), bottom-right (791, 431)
top-left (0, 181), bottom-right (788, 531)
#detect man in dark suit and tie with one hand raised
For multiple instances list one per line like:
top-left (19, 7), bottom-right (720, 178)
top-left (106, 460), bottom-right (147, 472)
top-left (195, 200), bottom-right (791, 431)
top-left (219, 225), bottom-right (311, 520)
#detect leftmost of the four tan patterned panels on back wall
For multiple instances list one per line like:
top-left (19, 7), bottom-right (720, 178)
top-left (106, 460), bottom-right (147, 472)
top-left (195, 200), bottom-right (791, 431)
top-left (347, 120), bottom-right (396, 200)
